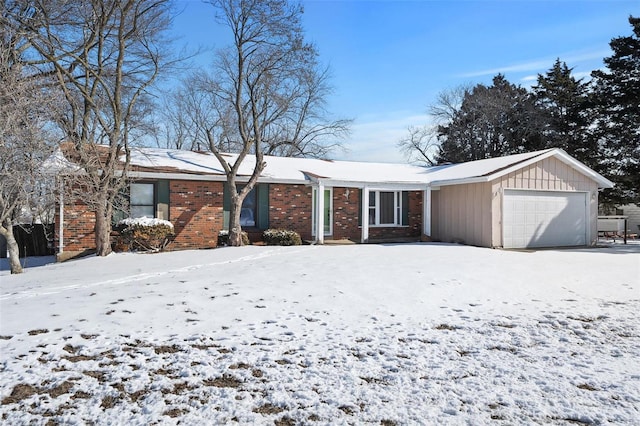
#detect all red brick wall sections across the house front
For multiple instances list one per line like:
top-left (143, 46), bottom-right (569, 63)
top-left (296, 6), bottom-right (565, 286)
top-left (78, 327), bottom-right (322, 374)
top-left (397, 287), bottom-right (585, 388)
top-left (56, 180), bottom-right (422, 252)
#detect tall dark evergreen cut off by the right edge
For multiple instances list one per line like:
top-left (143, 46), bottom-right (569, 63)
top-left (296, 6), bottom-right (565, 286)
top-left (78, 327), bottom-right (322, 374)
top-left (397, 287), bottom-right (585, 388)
top-left (592, 16), bottom-right (640, 207)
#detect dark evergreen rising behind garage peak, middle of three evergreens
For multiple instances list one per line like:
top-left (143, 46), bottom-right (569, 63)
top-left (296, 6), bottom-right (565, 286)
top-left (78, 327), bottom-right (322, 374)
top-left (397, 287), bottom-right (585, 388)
top-left (532, 59), bottom-right (598, 168)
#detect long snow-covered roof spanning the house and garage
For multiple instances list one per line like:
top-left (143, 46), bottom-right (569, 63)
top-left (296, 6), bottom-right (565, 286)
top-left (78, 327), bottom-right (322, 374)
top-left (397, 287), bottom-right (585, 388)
top-left (124, 148), bottom-right (613, 188)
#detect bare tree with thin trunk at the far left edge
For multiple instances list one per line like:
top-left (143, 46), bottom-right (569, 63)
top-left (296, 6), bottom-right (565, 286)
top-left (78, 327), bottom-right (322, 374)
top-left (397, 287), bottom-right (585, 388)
top-left (0, 12), bottom-right (58, 274)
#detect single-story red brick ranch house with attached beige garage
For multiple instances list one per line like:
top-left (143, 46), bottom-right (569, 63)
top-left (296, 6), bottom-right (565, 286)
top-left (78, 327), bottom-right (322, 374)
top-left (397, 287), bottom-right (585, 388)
top-left (51, 148), bottom-right (613, 258)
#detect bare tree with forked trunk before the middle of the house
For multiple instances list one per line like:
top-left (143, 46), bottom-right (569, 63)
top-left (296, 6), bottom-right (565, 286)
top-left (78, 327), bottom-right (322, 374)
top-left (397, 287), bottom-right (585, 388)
top-left (199, 0), bottom-right (349, 246)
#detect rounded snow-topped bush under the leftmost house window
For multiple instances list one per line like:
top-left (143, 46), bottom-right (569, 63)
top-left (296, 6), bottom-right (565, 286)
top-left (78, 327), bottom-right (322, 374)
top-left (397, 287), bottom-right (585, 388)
top-left (116, 217), bottom-right (175, 251)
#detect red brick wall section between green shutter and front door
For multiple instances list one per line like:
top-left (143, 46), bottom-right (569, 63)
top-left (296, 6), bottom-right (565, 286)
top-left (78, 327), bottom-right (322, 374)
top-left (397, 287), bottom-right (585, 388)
top-left (269, 183), bottom-right (312, 240)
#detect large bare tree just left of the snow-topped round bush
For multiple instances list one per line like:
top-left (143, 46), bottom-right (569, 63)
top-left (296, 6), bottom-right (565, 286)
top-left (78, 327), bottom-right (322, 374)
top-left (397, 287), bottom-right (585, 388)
top-left (5, 0), bottom-right (175, 256)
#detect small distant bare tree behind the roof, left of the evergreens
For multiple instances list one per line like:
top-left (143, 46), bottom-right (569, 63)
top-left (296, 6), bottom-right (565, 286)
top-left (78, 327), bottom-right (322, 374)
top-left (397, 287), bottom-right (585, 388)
top-left (398, 84), bottom-right (471, 166)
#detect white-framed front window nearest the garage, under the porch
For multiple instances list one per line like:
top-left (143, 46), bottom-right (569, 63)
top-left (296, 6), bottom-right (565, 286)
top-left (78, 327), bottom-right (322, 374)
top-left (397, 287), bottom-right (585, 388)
top-left (369, 191), bottom-right (409, 226)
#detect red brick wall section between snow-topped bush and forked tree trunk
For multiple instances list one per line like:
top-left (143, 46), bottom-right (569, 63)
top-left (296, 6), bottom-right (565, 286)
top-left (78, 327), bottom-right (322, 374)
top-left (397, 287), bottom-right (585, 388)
top-left (168, 180), bottom-right (224, 250)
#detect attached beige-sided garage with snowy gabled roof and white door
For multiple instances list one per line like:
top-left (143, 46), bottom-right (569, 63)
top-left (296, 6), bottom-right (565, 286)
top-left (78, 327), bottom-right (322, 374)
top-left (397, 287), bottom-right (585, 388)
top-left (425, 149), bottom-right (613, 248)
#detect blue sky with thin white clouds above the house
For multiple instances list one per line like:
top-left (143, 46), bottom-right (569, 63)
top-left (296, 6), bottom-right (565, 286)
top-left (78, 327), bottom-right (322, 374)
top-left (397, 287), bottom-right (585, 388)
top-left (174, 0), bottom-right (640, 162)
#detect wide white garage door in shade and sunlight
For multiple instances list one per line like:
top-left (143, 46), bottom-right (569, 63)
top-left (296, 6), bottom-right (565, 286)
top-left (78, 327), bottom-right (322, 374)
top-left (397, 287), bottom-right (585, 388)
top-left (502, 189), bottom-right (587, 248)
